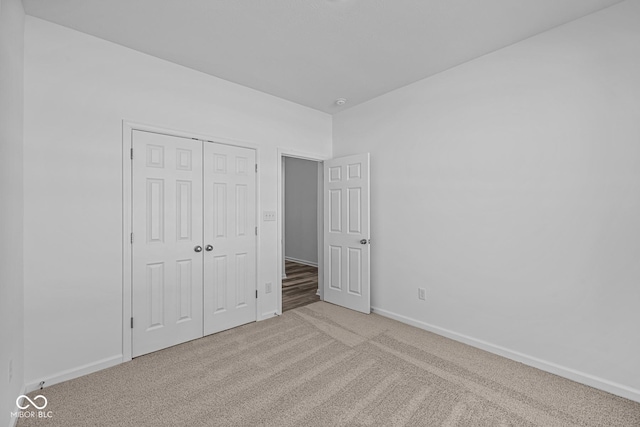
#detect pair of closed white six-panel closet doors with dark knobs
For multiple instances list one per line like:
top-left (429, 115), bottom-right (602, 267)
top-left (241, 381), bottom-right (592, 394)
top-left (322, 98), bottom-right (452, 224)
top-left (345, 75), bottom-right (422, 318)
top-left (132, 131), bottom-right (256, 357)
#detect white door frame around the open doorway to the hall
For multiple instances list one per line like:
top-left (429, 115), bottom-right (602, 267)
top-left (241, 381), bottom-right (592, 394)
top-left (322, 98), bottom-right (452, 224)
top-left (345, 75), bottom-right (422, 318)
top-left (275, 147), bottom-right (331, 315)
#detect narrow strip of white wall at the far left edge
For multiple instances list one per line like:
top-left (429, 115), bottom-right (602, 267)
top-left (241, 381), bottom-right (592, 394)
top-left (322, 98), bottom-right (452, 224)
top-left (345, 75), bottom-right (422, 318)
top-left (0, 0), bottom-right (24, 426)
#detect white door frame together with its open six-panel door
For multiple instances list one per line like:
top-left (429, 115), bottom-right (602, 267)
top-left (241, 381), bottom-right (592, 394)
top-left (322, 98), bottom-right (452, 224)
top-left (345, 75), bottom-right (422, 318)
top-left (278, 149), bottom-right (371, 314)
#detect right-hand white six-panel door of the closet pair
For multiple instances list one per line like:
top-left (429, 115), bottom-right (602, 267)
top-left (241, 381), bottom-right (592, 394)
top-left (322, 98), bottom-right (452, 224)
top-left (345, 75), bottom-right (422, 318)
top-left (204, 143), bottom-right (257, 335)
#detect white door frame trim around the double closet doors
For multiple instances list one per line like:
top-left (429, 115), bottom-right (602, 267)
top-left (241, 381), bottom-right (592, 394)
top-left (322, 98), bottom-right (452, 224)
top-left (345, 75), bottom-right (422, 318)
top-left (122, 120), bottom-right (262, 362)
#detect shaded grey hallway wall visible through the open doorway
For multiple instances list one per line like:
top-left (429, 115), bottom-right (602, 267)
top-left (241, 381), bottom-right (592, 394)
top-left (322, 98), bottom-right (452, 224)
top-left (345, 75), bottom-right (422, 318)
top-left (284, 157), bottom-right (318, 265)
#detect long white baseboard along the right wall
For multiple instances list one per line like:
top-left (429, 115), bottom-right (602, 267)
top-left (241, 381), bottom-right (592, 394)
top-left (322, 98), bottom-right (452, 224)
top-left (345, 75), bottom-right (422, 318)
top-left (371, 307), bottom-right (640, 402)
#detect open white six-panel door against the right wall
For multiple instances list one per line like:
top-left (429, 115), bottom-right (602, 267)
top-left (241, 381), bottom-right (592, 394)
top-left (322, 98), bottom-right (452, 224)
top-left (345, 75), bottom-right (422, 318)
top-left (324, 153), bottom-right (371, 314)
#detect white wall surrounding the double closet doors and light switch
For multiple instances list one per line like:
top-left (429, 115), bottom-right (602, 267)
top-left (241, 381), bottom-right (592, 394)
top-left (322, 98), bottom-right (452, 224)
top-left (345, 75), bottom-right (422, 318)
top-left (24, 17), bottom-right (331, 392)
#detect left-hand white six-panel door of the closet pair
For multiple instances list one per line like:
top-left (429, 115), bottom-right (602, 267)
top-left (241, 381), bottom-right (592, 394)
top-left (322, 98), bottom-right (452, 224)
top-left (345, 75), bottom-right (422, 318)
top-left (132, 131), bottom-right (204, 357)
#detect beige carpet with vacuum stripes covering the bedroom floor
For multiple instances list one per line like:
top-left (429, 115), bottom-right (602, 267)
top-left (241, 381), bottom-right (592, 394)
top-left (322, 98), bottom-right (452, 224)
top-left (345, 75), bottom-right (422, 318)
top-left (18, 302), bottom-right (640, 427)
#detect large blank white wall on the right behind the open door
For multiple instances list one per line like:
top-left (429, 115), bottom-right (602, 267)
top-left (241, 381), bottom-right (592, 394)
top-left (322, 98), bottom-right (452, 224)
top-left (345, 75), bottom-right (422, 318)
top-left (333, 0), bottom-right (640, 400)
